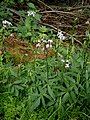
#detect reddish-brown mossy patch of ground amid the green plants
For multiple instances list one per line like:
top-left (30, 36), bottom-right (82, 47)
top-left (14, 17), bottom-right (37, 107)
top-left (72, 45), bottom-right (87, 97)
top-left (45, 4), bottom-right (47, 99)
top-left (4, 33), bottom-right (54, 64)
